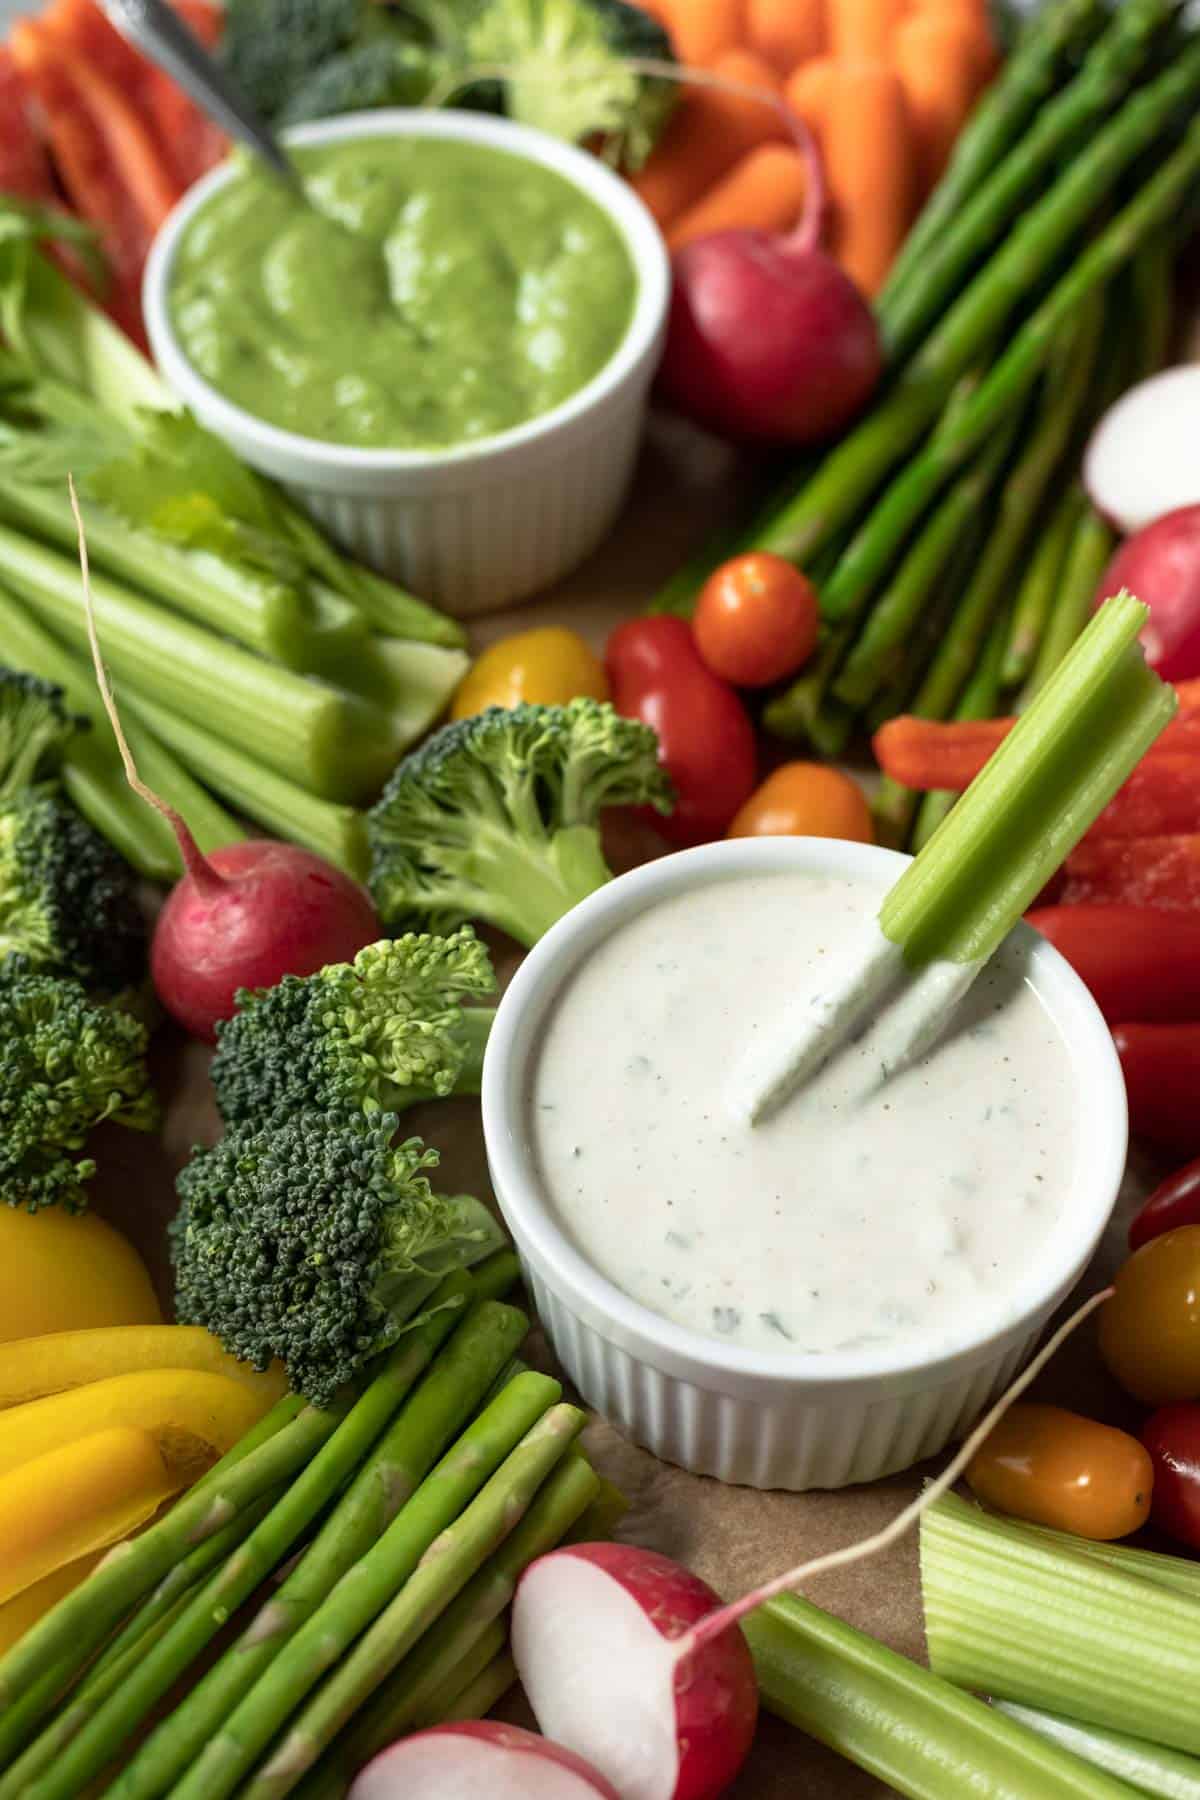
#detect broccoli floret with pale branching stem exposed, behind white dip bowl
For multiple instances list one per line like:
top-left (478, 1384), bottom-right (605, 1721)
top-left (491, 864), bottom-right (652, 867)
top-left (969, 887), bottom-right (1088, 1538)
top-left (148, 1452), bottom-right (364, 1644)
top-left (367, 698), bottom-right (671, 945)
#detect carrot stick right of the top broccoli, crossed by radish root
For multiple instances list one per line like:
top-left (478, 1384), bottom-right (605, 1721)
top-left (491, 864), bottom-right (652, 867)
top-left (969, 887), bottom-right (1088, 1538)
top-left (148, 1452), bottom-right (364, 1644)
top-left (631, 50), bottom-right (788, 230)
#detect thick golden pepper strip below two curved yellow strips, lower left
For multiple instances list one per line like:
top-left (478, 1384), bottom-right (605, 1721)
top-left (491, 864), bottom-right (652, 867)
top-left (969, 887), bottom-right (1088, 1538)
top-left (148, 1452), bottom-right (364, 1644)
top-left (0, 1426), bottom-right (180, 1600)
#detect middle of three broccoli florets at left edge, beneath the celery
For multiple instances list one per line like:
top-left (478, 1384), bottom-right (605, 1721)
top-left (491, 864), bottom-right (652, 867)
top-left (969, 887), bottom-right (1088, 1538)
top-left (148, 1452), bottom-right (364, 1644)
top-left (0, 788), bottom-right (146, 994)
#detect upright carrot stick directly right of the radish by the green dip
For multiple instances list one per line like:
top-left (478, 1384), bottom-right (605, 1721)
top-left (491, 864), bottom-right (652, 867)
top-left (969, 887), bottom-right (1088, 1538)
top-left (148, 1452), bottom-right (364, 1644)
top-left (819, 63), bottom-right (918, 295)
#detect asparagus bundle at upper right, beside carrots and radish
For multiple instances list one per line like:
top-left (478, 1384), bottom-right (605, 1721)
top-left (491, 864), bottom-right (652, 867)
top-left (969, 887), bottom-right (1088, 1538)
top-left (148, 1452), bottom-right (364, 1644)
top-left (657, 0), bottom-right (1200, 846)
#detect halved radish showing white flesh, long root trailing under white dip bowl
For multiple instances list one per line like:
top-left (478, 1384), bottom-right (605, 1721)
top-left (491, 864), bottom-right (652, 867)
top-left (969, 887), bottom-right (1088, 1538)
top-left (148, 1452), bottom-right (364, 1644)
top-left (510, 1289), bottom-right (1112, 1800)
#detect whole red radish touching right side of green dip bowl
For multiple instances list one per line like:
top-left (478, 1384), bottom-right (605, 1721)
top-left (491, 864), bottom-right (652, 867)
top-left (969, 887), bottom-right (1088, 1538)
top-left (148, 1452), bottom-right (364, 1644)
top-left (658, 72), bottom-right (883, 445)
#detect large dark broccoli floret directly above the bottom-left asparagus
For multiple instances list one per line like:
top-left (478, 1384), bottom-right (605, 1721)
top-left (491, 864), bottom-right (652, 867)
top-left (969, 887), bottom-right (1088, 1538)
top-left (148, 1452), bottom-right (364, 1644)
top-left (169, 1112), bottom-right (500, 1406)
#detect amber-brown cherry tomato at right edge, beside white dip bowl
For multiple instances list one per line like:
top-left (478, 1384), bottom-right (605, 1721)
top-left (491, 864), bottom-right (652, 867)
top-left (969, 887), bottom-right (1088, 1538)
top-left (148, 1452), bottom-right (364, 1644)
top-left (1099, 1226), bottom-right (1200, 1406)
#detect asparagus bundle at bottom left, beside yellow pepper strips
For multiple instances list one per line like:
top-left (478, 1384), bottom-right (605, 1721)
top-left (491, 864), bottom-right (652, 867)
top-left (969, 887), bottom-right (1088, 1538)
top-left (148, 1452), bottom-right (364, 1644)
top-left (0, 1251), bottom-right (621, 1800)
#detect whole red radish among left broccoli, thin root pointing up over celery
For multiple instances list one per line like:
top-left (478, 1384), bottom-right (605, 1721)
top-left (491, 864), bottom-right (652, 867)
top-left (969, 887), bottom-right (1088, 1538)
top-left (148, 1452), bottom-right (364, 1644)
top-left (70, 482), bottom-right (383, 1042)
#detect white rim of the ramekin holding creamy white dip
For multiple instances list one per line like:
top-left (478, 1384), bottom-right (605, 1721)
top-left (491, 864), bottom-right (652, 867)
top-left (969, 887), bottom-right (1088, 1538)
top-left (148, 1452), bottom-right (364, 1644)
top-left (482, 837), bottom-right (1128, 1400)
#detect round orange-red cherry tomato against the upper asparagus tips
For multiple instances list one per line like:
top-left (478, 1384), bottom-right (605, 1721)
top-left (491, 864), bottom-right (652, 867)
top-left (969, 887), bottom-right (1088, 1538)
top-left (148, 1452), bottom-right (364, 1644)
top-left (693, 551), bottom-right (820, 688)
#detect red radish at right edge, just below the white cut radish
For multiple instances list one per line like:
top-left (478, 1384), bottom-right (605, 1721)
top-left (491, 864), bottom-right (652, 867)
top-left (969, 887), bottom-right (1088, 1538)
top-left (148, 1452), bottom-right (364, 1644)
top-left (1096, 511), bottom-right (1200, 680)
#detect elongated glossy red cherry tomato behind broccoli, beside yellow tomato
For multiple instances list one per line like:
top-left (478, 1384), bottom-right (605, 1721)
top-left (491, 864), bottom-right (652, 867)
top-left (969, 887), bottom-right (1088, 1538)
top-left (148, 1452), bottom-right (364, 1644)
top-left (604, 614), bottom-right (757, 844)
